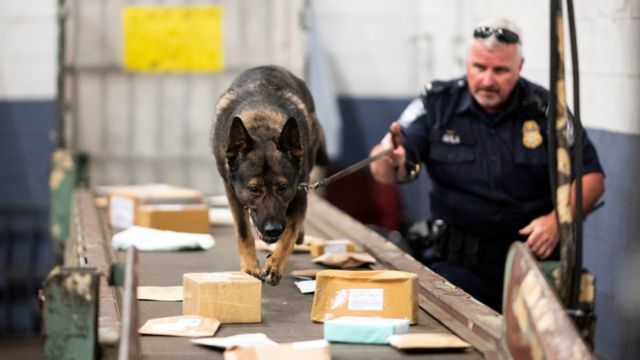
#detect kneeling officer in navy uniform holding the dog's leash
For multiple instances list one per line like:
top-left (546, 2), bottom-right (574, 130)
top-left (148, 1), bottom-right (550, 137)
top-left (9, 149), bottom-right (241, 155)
top-left (370, 19), bottom-right (604, 311)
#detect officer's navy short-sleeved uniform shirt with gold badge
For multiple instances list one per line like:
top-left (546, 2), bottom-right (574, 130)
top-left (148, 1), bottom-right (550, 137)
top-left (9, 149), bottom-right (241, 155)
top-left (399, 78), bottom-right (602, 241)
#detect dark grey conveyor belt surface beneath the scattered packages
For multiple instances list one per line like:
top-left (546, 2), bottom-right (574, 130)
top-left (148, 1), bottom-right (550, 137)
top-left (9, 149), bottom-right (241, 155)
top-left (72, 190), bottom-right (486, 360)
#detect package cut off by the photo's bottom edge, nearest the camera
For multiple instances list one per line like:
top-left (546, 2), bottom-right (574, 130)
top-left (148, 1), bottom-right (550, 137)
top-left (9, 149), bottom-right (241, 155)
top-left (224, 340), bottom-right (331, 360)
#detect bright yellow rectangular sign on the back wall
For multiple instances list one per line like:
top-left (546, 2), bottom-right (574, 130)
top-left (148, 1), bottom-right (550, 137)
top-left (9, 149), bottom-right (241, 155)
top-left (122, 5), bottom-right (223, 72)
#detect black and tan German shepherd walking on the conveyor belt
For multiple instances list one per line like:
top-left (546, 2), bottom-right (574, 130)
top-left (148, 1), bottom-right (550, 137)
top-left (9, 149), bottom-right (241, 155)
top-left (211, 66), bottom-right (328, 285)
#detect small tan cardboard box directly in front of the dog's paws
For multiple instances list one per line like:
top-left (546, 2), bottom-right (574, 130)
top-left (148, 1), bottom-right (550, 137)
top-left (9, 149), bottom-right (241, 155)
top-left (182, 271), bottom-right (262, 323)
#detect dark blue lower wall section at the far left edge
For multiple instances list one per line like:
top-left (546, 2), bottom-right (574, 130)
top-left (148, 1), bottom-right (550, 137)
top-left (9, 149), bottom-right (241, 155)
top-left (0, 101), bottom-right (56, 337)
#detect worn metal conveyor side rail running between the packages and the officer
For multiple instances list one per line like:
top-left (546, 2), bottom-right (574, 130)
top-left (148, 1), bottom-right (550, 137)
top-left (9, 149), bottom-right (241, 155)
top-left (307, 196), bottom-right (508, 358)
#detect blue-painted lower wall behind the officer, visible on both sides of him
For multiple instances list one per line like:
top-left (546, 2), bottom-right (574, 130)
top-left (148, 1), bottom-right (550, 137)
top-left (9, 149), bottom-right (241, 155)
top-left (329, 97), bottom-right (640, 359)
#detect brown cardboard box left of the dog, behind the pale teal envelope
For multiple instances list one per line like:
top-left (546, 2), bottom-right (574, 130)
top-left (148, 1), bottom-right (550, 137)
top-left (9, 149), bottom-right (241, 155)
top-left (134, 204), bottom-right (209, 234)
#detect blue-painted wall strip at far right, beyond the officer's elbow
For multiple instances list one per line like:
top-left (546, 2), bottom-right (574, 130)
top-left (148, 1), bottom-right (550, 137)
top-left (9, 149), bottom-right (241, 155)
top-left (584, 129), bottom-right (640, 359)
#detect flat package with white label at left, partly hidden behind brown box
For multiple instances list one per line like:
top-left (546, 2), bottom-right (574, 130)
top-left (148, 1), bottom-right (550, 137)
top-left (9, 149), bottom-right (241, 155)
top-left (107, 184), bottom-right (204, 229)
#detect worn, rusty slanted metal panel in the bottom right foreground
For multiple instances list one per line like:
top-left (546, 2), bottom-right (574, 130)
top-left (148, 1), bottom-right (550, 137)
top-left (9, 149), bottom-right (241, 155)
top-left (503, 242), bottom-right (593, 360)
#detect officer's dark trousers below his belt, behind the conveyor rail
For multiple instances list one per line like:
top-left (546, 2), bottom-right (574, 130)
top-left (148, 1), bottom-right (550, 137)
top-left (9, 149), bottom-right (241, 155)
top-left (427, 259), bottom-right (506, 312)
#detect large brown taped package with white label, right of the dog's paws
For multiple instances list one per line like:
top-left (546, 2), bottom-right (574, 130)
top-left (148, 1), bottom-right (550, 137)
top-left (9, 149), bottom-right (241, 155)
top-left (311, 270), bottom-right (418, 324)
